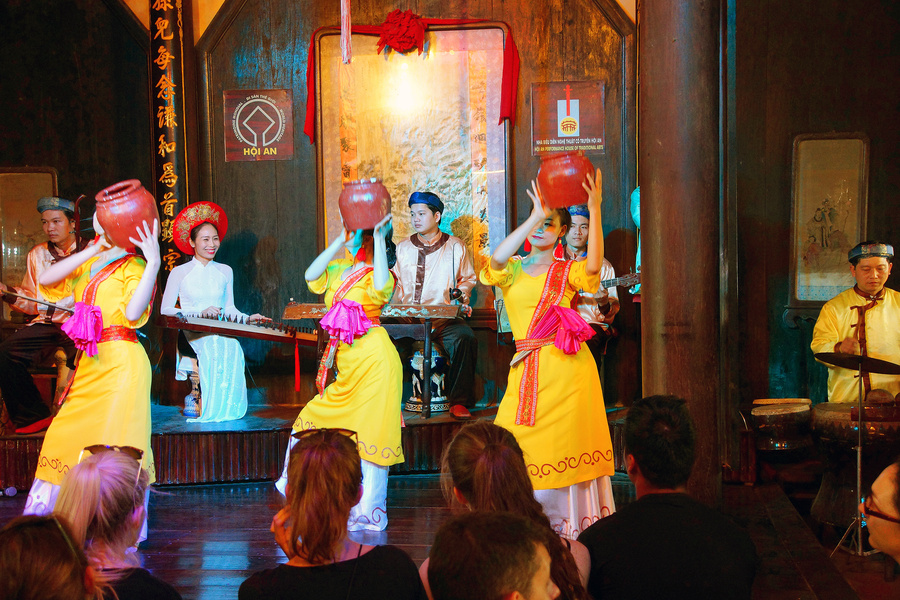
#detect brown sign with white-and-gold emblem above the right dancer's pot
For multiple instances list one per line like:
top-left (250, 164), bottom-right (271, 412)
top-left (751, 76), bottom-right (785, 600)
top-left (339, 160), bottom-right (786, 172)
top-left (531, 81), bottom-right (606, 156)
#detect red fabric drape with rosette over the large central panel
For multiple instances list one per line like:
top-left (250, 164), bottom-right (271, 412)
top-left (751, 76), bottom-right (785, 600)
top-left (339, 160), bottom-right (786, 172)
top-left (303, 18), bottom-right (519, 144)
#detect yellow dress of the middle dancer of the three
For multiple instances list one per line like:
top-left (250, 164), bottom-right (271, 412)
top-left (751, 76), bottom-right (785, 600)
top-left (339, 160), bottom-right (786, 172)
top-left (294, 260), bottom-right (404, 466)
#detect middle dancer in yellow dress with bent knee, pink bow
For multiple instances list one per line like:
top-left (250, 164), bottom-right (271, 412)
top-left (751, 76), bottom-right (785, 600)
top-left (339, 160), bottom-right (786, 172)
top-left (275, 215), bottom-right (404, 531)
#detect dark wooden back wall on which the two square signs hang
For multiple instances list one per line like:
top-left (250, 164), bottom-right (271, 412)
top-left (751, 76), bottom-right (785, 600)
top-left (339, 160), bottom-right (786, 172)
top-left (198, 0), bottom-right (640, 403)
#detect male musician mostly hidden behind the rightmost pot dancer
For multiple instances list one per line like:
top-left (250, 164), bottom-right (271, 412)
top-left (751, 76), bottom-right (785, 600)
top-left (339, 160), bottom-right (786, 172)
top-left (562, 204), bottom-right (619, 365)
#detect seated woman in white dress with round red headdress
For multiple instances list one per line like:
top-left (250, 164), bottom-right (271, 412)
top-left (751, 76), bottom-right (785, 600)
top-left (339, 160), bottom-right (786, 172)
top-left (160, 202), bottom-right (269, 423)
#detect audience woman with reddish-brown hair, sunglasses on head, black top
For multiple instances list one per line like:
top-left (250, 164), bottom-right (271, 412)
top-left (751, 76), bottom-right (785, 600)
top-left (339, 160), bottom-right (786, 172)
top-left (238, 429), bottom-right (425, 600)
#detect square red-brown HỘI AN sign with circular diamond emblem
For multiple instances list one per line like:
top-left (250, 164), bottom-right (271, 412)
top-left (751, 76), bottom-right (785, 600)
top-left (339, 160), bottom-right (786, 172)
top-left (222, 90), bottom-right (294, 162)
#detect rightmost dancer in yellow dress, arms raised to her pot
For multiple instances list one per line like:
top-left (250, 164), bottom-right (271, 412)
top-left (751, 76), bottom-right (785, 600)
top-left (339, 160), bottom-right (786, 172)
top-left (481, 169), bottom-right (615, 539)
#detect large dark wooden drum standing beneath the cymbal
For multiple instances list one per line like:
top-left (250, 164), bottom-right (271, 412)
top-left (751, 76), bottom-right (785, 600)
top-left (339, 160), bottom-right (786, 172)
top-left (810, 402), bottom-right (900, 527)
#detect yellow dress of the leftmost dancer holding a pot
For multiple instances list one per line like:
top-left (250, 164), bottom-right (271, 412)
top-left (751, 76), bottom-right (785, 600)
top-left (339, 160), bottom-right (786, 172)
top-left (35, 256), bottom-right (156, 485)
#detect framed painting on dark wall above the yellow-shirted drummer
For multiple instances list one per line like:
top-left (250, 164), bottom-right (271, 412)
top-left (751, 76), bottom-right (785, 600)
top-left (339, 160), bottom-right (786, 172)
top-left (788, 133), bottom-right (869, 308)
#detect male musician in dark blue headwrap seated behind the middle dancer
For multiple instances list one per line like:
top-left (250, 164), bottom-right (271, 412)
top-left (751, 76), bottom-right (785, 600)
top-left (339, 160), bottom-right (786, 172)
top-left (392, 192), bottom-right (478, 418)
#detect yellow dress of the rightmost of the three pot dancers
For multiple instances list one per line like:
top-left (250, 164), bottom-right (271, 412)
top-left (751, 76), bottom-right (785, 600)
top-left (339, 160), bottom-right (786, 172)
top-left (481, 257), bottom-right (615, 490)
